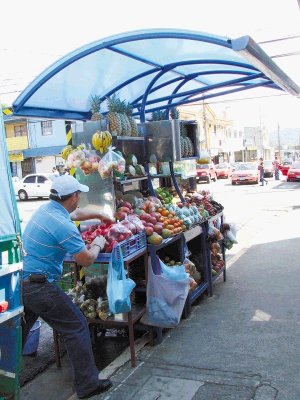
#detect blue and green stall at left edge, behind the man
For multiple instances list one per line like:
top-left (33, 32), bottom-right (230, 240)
top-left (0, 108), bottom-right (23, 399)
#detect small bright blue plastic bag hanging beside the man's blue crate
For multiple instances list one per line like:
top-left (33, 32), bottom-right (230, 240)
top-left (106, 246), bottom-right (135, 314)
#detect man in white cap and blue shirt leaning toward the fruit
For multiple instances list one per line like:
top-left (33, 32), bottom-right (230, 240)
top-left (22, 175), bottom-right (112, 399)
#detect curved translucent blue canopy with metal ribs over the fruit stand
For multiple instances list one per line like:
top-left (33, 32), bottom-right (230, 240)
top-left (13, 29), bottom-right (300, 120)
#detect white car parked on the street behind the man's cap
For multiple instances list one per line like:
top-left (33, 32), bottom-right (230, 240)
top-left (13, 174), bottom-right (56, 201)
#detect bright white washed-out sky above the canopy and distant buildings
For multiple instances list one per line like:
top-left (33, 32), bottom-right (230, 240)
top-left (0, 0), bottom-right (300, 130)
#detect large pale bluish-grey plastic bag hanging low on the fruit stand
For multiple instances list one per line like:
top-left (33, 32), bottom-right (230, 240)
top-left (141, 257), bottom-right (190, 328)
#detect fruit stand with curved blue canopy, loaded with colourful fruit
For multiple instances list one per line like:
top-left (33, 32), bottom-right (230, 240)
top-left (13, 29), bottom-right (299, 365)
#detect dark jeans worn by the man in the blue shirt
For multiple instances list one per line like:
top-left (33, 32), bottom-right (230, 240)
top-left (23, 282), bottom-right (99, 396)
